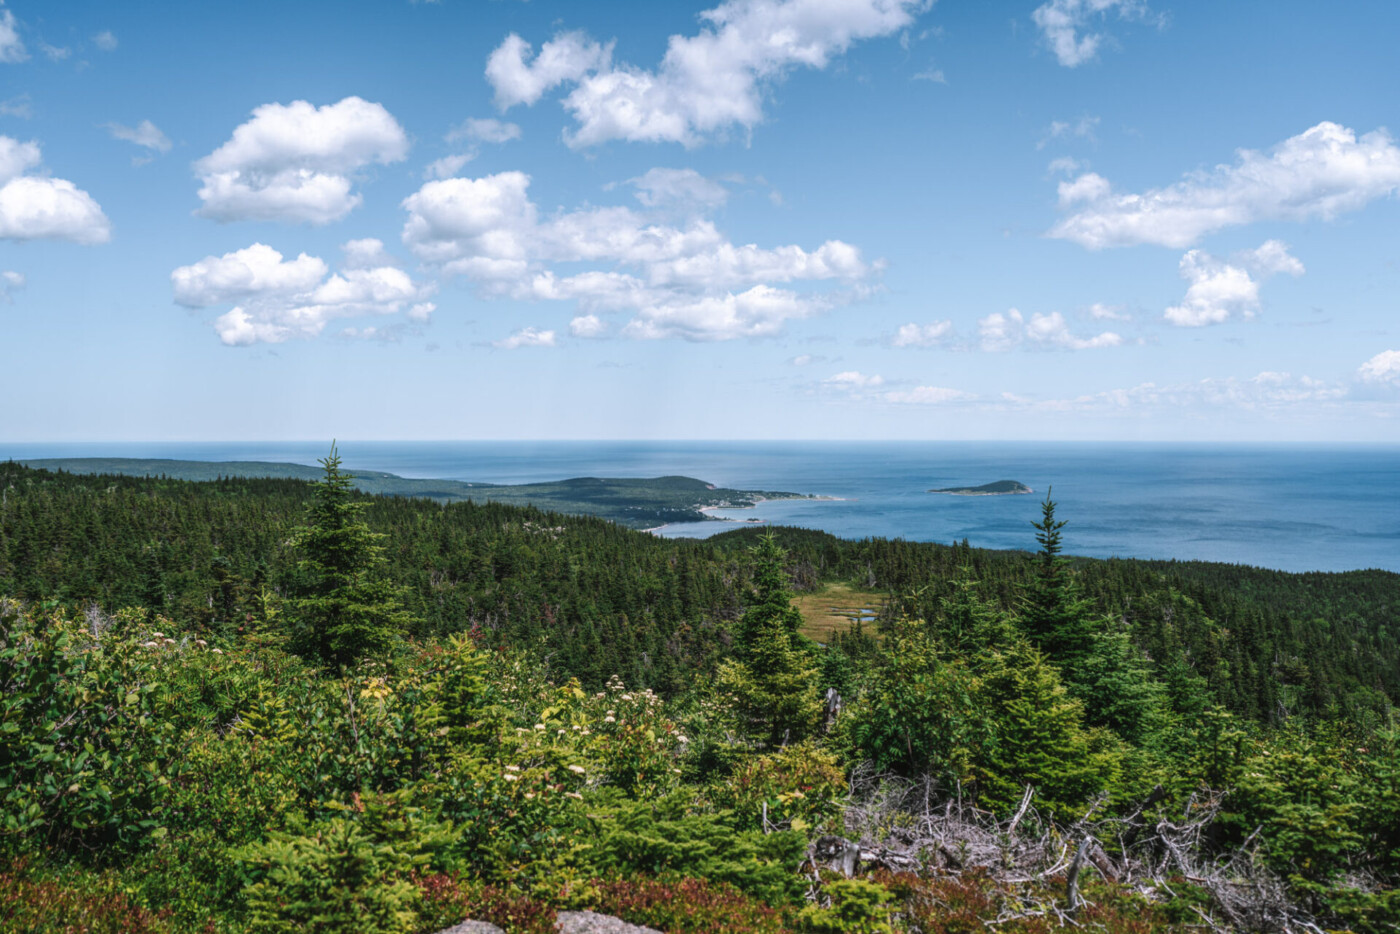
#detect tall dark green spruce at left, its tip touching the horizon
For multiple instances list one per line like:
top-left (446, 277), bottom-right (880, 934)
top-left (287, 444), bottom-right (413, 668)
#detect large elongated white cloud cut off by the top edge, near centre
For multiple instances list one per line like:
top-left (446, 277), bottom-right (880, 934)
top-left (486, 0), bottom-right (928, 147)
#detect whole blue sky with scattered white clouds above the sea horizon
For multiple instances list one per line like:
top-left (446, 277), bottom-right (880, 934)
top-left (0, 0), bottom-right (1400, 442)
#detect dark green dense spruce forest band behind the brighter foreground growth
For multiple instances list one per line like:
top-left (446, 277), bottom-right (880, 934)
top-left (8, 463), bottom-right (1400, 721)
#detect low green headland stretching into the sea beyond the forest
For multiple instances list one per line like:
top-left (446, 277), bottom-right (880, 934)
top-left (21, 458), bottom-right (808, 529)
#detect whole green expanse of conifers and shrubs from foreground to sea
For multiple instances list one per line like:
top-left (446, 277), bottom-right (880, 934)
top-left (0, 452), bottom-right (1400, 934)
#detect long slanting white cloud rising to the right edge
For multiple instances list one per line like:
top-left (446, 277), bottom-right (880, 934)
top-left (1050, 122), bottom-right (1400, 249)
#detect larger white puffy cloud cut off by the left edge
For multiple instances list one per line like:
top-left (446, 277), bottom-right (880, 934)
top-left (0, 136), bottom-right (112, 244)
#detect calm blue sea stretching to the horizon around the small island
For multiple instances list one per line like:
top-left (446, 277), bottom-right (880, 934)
top-left (0, 441), bottom-right (1400, 571)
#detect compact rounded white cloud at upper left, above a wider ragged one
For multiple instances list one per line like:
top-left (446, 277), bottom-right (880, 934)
top-left (195, 97), bottom-right (409, 224)
